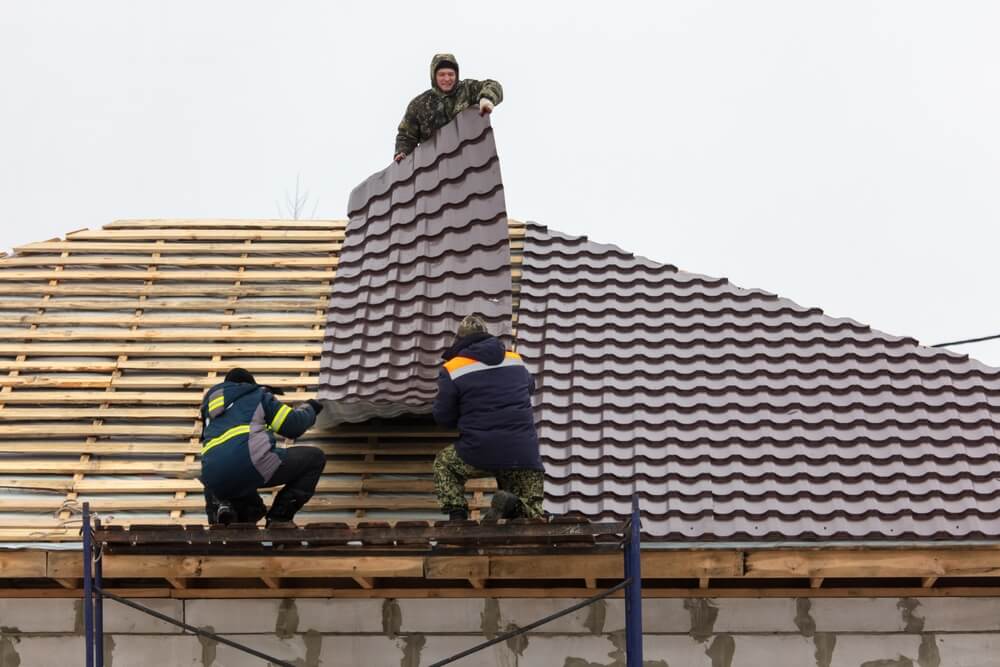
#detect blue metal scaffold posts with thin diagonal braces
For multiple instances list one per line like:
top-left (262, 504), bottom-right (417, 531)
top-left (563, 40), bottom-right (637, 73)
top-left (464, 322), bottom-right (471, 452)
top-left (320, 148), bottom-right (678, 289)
top-left (83, 498), bottom-right (642, 667)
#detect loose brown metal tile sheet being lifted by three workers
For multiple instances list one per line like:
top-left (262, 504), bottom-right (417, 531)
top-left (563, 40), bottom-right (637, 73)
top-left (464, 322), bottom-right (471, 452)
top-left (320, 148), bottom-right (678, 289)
top-left (319, 109), bottom-right (511, 421)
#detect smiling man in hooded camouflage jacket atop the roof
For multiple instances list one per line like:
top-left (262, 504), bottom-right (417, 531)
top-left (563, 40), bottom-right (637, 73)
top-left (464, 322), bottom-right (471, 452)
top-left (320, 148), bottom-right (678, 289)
top-left (393, 53), bottom-right (503, 162)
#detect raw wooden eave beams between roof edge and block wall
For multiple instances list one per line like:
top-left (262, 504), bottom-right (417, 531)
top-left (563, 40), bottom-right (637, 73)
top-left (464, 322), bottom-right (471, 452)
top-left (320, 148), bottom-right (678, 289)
top-left (0, 547), bottom-right (1000, 597)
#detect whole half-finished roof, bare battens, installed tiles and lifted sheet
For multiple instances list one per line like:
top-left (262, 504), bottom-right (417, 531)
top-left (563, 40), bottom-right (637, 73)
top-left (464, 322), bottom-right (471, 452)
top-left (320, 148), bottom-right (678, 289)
top-left (0, 112), bottom-right (1000, 544)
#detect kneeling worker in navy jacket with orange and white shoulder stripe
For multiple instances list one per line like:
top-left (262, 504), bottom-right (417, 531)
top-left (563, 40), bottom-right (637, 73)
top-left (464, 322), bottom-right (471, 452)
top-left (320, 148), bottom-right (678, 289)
top-left (434, 315), bottom-right (545, 521)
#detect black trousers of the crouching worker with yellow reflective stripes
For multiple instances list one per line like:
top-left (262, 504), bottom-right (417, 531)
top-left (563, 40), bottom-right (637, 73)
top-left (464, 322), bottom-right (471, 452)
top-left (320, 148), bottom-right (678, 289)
top-left (205, 446), bottom-right (326, 523)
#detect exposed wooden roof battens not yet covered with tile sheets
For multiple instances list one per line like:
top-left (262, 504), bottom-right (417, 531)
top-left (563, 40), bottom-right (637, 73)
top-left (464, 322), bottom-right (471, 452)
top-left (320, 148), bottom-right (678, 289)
top-left (0, 220), bottom-right (523, 542)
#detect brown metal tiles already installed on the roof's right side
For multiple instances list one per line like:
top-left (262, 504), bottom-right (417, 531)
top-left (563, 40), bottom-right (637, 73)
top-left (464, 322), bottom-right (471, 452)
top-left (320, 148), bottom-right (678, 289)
top-left (516, 225), bottom-right (1000, 541)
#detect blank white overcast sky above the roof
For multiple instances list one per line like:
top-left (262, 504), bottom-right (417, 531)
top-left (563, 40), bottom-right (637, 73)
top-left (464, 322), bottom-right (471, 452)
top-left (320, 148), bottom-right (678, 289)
top-left (0, 0), bottom-right (1000, 365)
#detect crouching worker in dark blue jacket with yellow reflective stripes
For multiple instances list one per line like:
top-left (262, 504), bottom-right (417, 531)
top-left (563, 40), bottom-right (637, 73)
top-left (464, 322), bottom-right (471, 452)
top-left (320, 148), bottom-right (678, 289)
top-left (201, 368), bottom-right (326, 527)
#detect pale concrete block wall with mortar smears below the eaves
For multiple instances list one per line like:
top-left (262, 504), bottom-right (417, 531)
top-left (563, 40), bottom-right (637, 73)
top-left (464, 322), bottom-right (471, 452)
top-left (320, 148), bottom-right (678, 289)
top-left (0, 598), bottom-right (1000, 667)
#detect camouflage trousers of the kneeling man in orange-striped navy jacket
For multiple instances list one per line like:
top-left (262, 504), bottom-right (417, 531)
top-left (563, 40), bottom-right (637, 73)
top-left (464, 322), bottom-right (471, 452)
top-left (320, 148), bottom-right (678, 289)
top-left (434, 445), bottom-right (545, 519)
